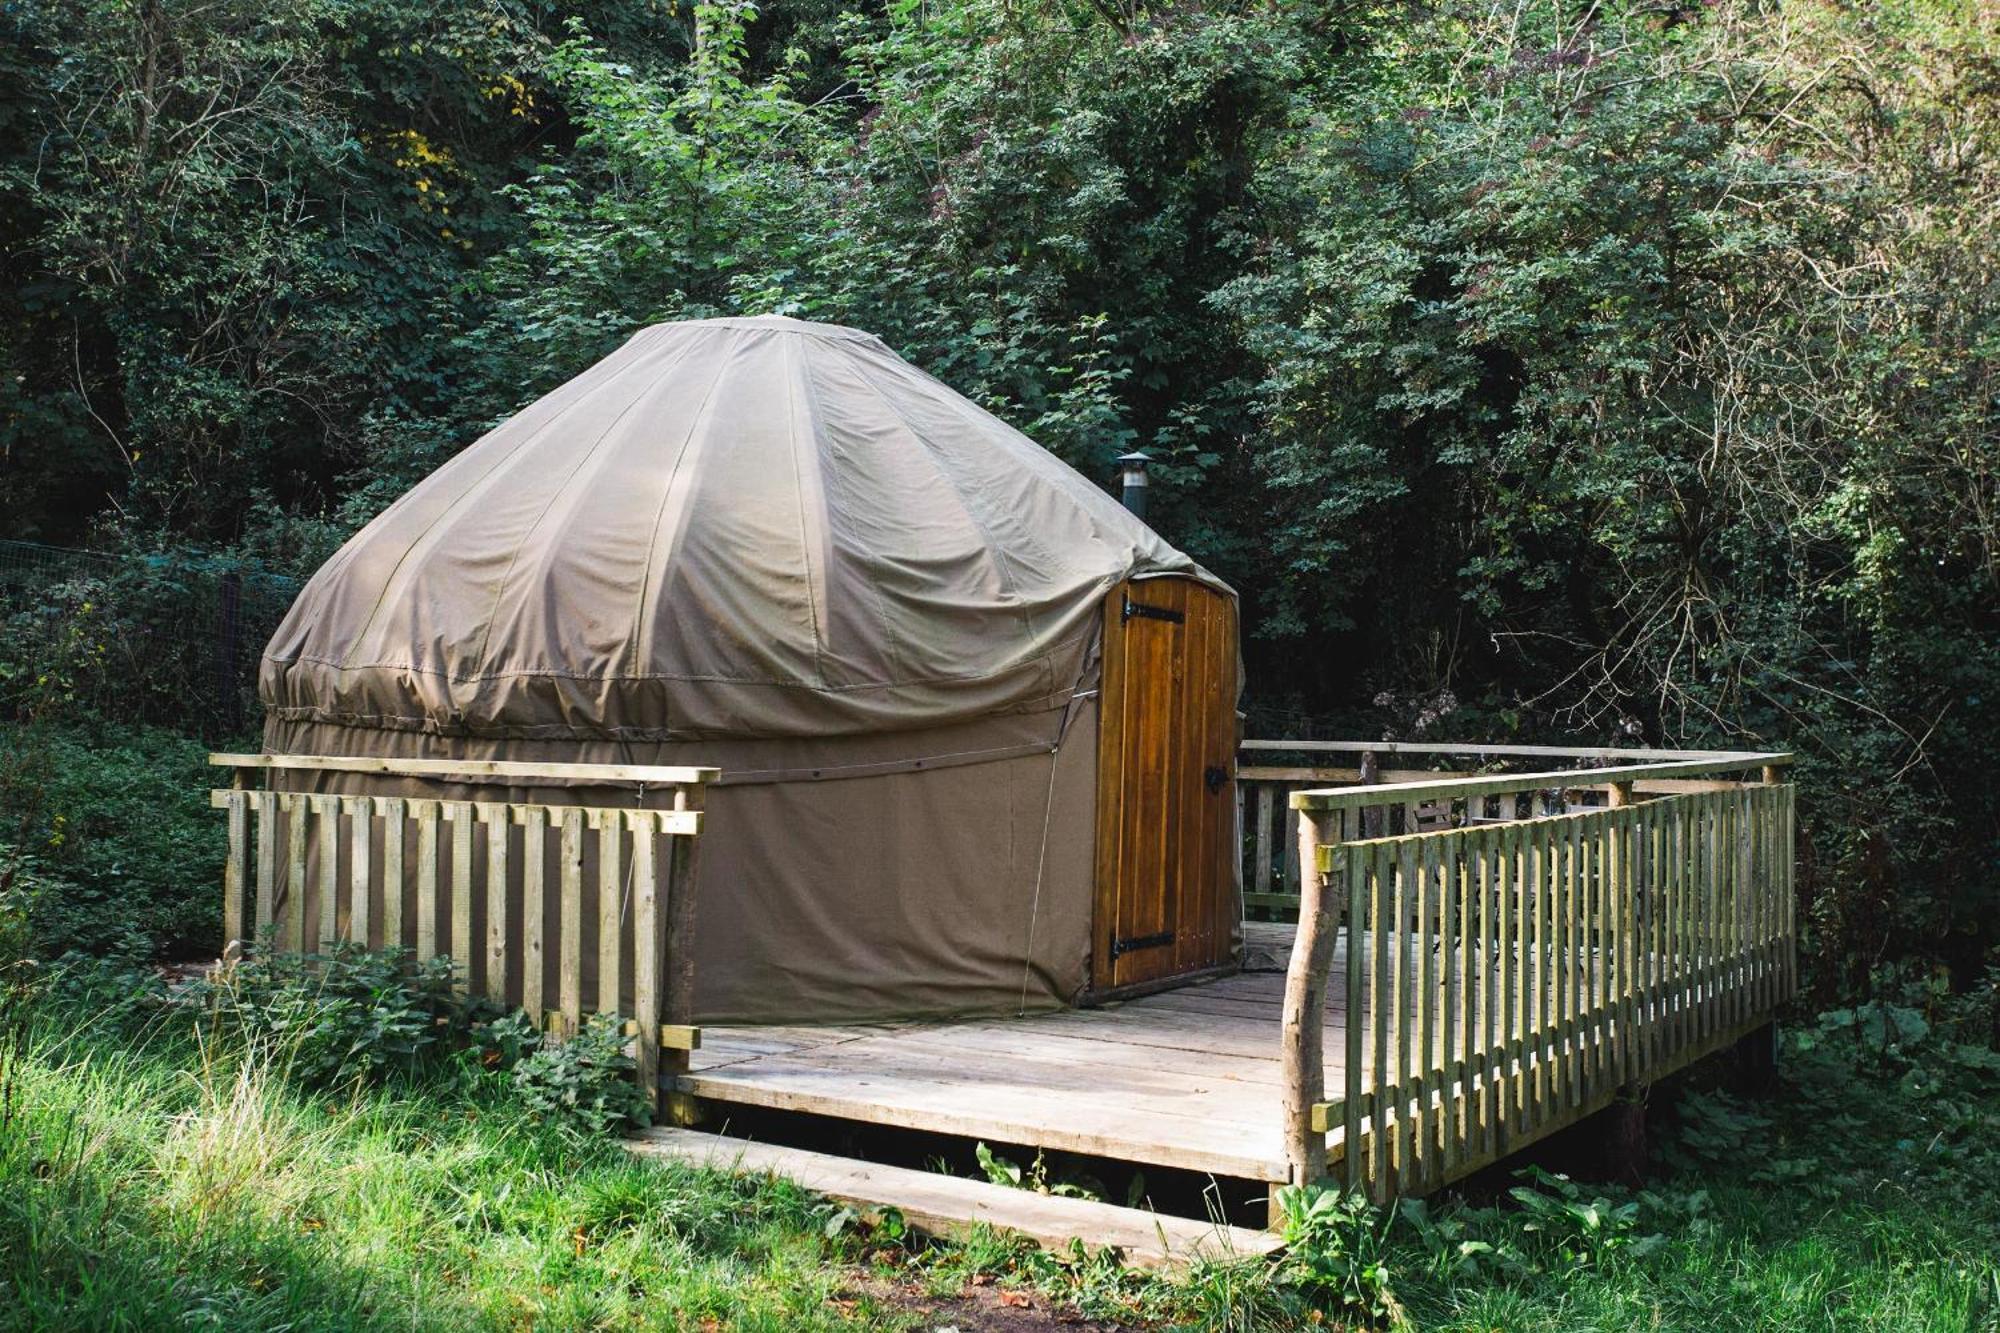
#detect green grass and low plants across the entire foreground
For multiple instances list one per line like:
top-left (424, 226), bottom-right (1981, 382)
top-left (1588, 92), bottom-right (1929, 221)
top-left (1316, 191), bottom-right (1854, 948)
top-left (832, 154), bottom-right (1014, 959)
top-left (0, 964), bottom-right (2000, 1333)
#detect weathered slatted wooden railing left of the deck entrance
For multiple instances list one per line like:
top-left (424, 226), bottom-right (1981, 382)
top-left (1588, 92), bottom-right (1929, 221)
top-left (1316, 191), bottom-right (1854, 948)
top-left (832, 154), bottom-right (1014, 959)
top-left (210, 755), bottom-right (716, 1099)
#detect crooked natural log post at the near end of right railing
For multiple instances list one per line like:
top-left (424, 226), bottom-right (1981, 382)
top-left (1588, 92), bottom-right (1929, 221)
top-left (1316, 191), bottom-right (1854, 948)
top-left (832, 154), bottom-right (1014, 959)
top-left (1284, 811), bottom-right (1346, 1185)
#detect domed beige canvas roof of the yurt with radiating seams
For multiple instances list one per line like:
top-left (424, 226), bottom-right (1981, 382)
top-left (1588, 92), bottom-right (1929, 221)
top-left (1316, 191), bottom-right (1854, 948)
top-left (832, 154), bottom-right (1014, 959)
top-left (262, 316), bottom-right (1200, 743)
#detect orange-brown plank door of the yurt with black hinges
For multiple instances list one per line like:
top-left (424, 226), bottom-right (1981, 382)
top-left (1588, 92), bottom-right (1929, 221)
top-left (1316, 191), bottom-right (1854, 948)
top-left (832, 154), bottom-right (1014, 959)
top-left (1092, 578), bottom-right (1236, 995)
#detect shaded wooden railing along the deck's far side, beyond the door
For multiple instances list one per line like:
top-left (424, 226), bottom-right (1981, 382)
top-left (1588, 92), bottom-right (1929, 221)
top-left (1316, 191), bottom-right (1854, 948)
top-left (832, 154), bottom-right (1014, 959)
top-left (1236, 741), bottom-right (1776, 921)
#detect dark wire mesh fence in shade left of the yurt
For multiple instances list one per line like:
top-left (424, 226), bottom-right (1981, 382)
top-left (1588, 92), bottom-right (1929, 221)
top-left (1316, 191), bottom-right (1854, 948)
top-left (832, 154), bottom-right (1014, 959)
top-left (0, 540), bottom-right (300, 739)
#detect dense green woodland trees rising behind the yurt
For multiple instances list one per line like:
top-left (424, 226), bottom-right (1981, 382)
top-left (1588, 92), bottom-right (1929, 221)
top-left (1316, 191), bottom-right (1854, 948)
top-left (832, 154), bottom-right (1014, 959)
top-left (0, 0), bottom-right (2000, 993)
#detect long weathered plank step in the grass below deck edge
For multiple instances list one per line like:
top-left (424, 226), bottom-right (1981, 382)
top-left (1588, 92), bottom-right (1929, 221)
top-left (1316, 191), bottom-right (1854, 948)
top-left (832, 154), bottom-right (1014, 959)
top-left (626, 1127), bottom-right (1280, 1269)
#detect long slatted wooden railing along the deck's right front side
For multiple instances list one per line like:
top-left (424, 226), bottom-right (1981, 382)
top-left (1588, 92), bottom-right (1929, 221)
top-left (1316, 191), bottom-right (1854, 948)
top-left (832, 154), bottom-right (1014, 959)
top-left (1284, 755), bottom-right (1796, 1199)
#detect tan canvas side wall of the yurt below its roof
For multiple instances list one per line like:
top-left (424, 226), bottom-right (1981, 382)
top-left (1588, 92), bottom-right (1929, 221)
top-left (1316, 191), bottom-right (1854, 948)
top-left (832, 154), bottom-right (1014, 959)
top-left (266, 699), bottom-right (1096, 1023)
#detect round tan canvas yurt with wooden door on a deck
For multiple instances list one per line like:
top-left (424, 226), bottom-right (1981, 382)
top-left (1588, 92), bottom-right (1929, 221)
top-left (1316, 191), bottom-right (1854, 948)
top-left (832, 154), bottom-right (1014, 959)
top-left (260, 318), bottom-right (1240, 1023)
